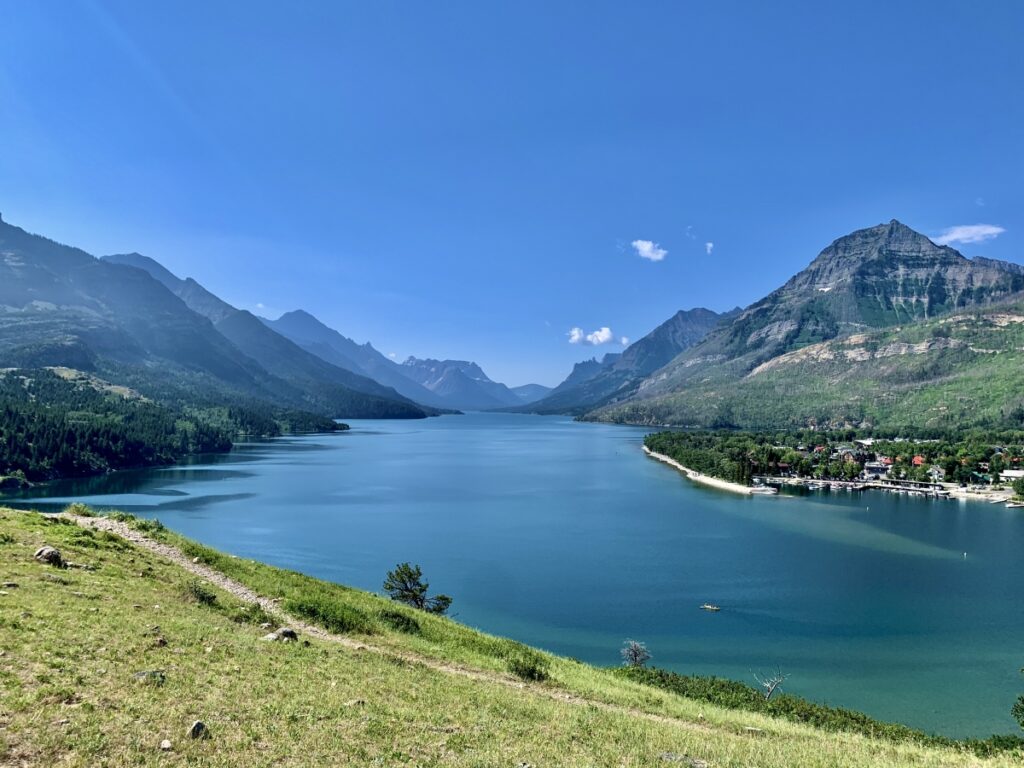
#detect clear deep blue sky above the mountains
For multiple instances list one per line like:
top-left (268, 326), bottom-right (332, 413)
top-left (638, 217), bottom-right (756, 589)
top-left (0, 0), bottom-right (1024, 384)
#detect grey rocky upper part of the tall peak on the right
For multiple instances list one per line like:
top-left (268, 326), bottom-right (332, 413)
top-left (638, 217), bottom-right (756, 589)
top-left (640, 219), bottom-right (1024, 394)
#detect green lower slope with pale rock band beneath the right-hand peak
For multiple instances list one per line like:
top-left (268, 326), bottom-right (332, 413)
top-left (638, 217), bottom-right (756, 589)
top-left (592, 303), bottom-right (1024, 433)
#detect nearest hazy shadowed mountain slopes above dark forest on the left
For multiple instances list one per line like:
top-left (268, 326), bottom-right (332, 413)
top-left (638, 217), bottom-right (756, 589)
top-left (0, 218), bottom-right (425, 418)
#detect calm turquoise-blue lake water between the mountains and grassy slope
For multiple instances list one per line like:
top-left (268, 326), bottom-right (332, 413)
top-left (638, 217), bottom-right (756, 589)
top-left (8, 414), bottom-right (1024, 736)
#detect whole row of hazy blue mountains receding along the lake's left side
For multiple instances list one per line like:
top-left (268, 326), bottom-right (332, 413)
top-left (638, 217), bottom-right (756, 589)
top-left (0, 217), bottom-right (544, 419)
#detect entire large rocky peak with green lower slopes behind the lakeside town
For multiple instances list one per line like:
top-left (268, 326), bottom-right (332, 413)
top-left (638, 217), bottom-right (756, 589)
top-left (577, 220), bottom-right (1024, 430)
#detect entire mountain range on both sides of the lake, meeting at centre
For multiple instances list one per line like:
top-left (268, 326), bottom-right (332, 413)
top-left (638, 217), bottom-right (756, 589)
top-left (0, 211), bottom-right (1024, 430)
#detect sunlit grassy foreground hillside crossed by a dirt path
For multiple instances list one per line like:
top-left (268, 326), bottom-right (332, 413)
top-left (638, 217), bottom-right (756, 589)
top-left (0, 510), bottom-right (1020, 768)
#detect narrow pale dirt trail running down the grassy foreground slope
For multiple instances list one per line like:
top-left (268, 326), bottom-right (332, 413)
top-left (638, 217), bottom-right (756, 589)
top-left (68, 513), bottom-right (712, 732)
